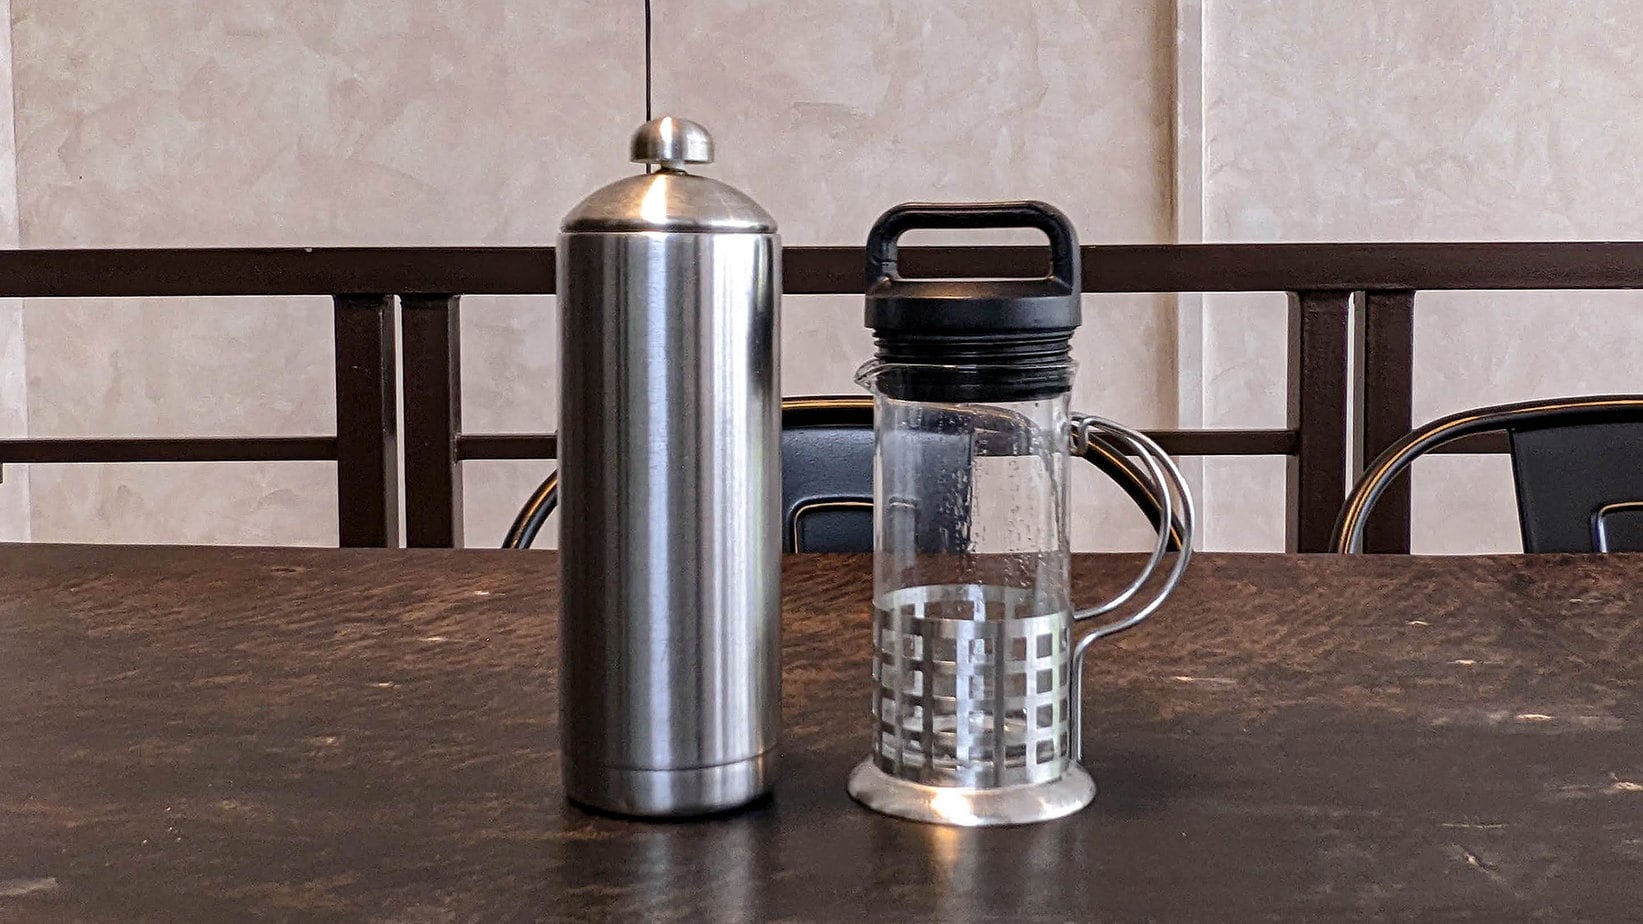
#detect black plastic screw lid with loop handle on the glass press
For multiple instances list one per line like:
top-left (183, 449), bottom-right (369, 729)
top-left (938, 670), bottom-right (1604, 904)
top-left (866, 202), bottom-right (1081, 401)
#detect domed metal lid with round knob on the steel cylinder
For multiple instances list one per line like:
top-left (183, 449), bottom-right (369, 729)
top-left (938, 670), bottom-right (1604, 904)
top-left (560, 117), bottom-right (775, 233)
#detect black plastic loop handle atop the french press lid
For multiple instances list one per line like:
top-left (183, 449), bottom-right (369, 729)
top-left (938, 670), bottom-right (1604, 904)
top-left (868, 201), bottom-right (1079, 293)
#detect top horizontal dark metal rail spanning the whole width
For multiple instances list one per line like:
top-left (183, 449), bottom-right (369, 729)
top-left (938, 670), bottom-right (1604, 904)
top-left (0, 242), bottom-right (1643, 298)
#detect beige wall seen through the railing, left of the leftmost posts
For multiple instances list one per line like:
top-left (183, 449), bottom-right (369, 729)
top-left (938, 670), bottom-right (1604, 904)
top-left (26, 298), bottom-right (337, 544)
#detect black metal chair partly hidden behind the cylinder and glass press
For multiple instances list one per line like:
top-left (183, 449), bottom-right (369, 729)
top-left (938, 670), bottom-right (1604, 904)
top-left (503, 396), bottom-right (1181, 552)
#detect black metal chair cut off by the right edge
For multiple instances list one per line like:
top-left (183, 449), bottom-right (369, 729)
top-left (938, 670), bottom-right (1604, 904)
top-left (1331, 395), bottom-right (1643, 552)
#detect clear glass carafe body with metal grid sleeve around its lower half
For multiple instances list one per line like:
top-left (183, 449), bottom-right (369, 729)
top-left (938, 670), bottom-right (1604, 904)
top-left (859, 362), bottom-right (1073, 788)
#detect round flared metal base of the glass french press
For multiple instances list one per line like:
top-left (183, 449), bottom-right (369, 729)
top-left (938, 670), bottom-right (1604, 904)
top-left (849, 758), bottom-right (1096, 827)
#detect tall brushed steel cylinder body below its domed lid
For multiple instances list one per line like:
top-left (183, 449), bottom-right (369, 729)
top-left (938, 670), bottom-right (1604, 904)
top-left (559, 228), bottom-right (780, 815)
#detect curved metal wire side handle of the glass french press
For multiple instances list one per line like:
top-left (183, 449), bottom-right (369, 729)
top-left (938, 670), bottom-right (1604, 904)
top-left (1068, 414), bottom-right (1196, 760)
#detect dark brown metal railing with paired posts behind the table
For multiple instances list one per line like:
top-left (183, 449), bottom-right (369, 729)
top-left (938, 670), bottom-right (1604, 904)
top-left (0, 243), bottom-right (1643, 551)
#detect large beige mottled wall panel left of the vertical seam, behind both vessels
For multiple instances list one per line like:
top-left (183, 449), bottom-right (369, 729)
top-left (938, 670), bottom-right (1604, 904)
top-left (13, 0), bottom-right (1175, 544)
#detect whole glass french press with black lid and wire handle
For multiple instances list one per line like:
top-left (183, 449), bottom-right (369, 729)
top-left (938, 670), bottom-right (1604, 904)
top-left (849, 202), bottom-right (1193, 825)
